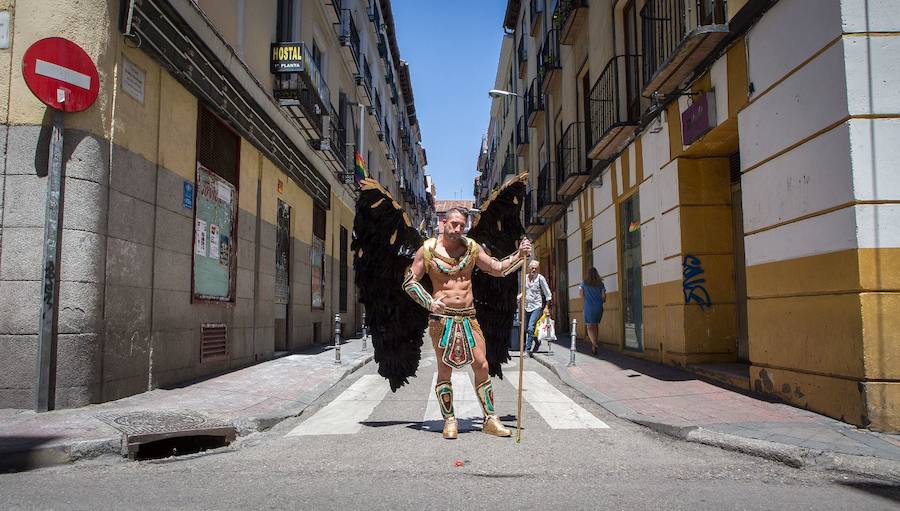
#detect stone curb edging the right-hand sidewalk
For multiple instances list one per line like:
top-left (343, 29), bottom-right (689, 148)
top-left (534, 354), bottom-right (900, 481)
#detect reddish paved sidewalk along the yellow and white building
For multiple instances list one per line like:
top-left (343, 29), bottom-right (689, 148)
top-left (534, 342), bottom-right (900, 479)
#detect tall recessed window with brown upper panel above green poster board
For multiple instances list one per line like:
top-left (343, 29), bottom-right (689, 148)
top-left (191, 105), bottom-right (240, 302)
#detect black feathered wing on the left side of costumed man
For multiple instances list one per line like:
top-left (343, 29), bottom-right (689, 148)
top-left (351, 179), bottom-right (430, 391)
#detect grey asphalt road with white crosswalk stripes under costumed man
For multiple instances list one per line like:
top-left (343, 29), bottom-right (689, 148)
top-left (0, 353), bottom-right (900, 511)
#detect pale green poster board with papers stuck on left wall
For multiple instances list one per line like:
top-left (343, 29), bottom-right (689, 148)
top-left (194, 163), bottom-right (237, 301)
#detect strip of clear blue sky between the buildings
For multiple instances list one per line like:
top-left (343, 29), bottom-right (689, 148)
top-left (391, 0), bottom-right (506, 199)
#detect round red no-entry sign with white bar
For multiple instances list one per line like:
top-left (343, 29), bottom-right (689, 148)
top-left (22, 37), bottom-right (100, 112)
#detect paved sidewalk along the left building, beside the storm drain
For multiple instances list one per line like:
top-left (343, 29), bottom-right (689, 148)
top-left (0, 339), bottom-right (373, 470)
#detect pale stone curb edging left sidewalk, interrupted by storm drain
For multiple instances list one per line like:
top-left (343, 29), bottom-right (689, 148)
top-left (0, 353), bottom-right (375, 472)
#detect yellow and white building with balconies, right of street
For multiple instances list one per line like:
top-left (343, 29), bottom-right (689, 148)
top-left (486, 0), bottom-right (900, 431)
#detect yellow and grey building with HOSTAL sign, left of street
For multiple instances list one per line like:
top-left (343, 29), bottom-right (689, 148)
top-left (0, 0), bottom-right (433, 408)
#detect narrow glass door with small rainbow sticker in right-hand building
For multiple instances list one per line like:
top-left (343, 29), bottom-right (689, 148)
top-left (619, 193), bottom-right (644, 351)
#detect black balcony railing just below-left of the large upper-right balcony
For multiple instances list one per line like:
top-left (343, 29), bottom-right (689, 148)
top-left (586, 55), bottom-right (641, 160)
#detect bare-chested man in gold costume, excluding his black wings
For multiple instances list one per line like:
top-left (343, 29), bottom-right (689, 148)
top-left (403, 208), bottom-right (531, 439)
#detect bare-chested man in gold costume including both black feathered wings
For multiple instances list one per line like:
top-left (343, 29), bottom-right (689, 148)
top-left (351, 173), bottom-right (531, 438)
